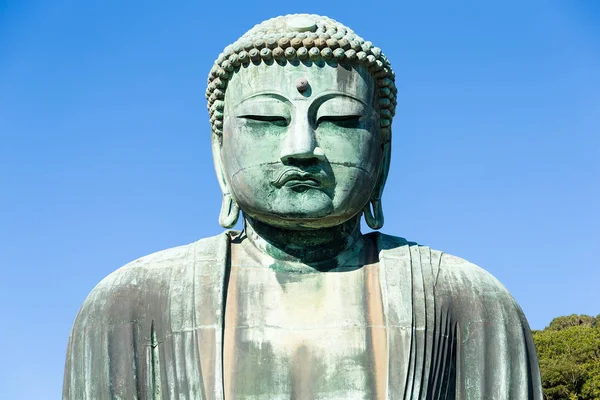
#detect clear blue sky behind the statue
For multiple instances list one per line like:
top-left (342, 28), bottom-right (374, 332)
top-left (0, 0), bottom-right (600, 400)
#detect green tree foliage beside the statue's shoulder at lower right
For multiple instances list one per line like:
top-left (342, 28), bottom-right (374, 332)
top-left (533, 315), bottom-right (600, 400)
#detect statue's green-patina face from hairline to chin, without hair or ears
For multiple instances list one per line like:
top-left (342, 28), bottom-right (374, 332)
top-left (217, 63), bottom-right (382, 229)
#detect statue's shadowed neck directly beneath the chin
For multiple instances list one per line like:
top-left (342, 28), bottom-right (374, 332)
top-left (244, 214), bottom-right (361, 264)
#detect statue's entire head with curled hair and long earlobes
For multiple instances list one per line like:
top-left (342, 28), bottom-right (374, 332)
top-left (206, 14), bottom-right (396, 229)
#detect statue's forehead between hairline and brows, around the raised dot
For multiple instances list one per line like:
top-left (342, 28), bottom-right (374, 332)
top-left (225, 63), bottom-right (375, 105)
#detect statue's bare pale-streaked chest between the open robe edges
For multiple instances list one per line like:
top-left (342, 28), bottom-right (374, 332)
top-left (224, 265), bottom-right (384, 399)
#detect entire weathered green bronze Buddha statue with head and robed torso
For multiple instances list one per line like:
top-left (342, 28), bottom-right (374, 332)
top-left (63, 14), bottom-right (542, 400)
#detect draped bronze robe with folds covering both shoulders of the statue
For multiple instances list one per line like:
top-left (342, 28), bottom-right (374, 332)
top-left (63, 232), bottom-right (542, 400)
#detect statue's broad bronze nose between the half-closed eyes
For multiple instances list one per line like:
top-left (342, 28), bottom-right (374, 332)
top-left (279, 117), bottom-right (325, 164)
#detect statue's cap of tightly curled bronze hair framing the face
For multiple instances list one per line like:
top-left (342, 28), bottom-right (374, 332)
top-left (206, 14), bottom-right (397, 141)
